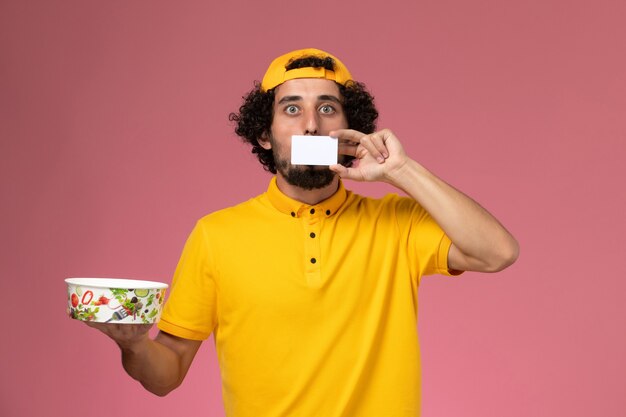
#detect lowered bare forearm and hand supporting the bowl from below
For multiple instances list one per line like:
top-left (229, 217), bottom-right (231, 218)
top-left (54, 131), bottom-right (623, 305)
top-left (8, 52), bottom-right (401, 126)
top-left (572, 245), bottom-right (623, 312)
top-left (87, 322), bottom-right (202, 396)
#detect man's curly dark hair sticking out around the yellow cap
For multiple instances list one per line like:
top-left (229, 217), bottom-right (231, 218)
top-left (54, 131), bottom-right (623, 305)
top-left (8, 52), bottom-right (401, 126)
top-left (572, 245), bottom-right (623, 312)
top-left (228, 56), bottom-right (378, 174)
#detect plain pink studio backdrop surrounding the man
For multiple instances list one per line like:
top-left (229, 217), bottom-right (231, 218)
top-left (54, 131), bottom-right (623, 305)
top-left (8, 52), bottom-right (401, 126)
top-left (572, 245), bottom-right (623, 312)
top-left (0, 0), bottom-right (626, 417)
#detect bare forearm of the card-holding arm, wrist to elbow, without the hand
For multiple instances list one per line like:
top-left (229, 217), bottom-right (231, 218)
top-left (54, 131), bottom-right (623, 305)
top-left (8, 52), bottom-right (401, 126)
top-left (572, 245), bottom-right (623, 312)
top-left (387, 159), bottom-right (519, 272)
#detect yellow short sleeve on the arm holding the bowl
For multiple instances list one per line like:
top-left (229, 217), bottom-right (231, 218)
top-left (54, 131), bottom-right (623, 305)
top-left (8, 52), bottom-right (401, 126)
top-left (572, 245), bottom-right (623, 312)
top-left (158, 221), bottom-right (217, 340)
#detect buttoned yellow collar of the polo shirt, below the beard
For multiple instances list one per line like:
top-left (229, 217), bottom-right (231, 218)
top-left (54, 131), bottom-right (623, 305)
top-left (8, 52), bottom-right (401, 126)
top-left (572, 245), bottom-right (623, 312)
top-left (267, 177), bottom-right (348, 217)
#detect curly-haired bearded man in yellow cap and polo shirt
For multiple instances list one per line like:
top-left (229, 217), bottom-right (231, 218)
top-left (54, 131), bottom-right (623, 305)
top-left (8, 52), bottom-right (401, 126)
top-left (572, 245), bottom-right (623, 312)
top-left (90, 49), bottom-right (518, 417)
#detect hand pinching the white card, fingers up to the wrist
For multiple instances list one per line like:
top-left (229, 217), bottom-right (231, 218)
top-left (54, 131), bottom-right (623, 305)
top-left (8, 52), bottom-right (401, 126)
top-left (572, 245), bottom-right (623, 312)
top-left (329, 129), bottom-right (409, 182)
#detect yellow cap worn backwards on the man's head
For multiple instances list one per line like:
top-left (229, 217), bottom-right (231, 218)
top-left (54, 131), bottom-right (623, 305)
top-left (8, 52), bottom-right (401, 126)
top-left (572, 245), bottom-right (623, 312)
top-left (261, 48), bottom-right (352, 91)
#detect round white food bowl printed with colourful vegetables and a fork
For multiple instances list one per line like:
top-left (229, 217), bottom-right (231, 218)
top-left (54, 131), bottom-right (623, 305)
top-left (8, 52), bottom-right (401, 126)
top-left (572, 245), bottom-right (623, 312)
top-left (65, 278), bottom-right (168, 324)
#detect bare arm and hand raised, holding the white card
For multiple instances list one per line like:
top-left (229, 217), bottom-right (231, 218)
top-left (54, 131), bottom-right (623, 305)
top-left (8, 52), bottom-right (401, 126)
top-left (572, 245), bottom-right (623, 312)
top-left (329, 129), bottom-right (519, 272)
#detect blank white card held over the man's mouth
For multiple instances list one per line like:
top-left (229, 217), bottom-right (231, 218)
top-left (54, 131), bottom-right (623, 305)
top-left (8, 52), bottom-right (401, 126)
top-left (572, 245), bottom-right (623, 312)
top-left (291, 135), bottom-right (339, 165)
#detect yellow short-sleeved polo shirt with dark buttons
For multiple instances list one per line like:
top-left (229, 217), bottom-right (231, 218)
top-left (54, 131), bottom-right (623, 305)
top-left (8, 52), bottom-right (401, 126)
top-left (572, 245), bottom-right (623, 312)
top-left (159, 178), bottom-right (450, 417)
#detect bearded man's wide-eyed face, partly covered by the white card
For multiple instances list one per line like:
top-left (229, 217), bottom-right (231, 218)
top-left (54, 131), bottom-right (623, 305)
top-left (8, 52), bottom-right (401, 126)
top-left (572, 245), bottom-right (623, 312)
top-left (260, 78), bottom-right (348, 190)
